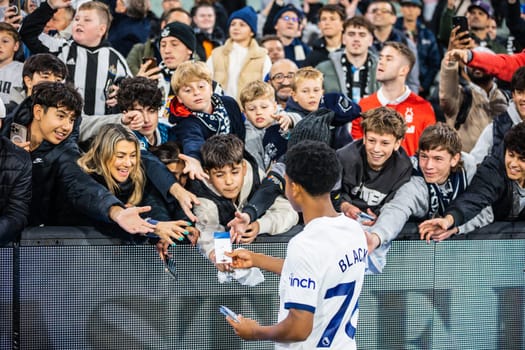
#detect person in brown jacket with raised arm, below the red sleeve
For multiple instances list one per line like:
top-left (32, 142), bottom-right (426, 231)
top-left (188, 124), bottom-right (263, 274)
top-left (439, 47), bottom-right (508, 152)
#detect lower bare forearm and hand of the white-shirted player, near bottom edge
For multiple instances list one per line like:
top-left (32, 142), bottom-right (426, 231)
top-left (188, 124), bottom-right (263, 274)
top-left (226, 309), bottom-right (314, 343)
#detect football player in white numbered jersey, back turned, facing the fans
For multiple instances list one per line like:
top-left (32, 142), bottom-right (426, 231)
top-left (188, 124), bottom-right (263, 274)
top-left (227, 141), bottom-right (367, 349)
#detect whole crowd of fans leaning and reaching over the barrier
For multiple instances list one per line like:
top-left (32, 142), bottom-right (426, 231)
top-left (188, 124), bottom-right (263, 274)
top-left (0, 0), bottom-right (525, 273)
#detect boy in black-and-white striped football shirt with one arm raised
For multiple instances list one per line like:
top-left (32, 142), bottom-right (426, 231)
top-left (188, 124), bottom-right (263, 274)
top-left (20, 0), bottom-right (132, 115)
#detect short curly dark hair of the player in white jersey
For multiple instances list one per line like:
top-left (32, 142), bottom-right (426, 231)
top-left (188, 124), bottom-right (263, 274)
top-left (285, 140), bottom-right (342, 196)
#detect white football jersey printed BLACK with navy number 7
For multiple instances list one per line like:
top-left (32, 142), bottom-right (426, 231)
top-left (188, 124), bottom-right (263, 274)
top-left (275, 215), bottom-right (368, 350)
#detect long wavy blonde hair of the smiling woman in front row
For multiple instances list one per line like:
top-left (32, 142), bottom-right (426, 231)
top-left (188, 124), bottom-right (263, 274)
top-left (77, 124), bottom-right (145, 205)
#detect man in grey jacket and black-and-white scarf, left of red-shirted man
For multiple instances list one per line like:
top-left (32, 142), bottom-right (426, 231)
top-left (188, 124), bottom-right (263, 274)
top-left (316, 16), bottom-right (379, 103)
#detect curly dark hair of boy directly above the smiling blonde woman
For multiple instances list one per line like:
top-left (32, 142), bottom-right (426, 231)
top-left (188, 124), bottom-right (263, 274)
top-left (117, 77), bottom-right (162, 111)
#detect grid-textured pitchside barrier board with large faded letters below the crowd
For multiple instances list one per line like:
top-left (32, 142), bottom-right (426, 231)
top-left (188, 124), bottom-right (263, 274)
top-left (0, 223), bottom-right (525, 350)
